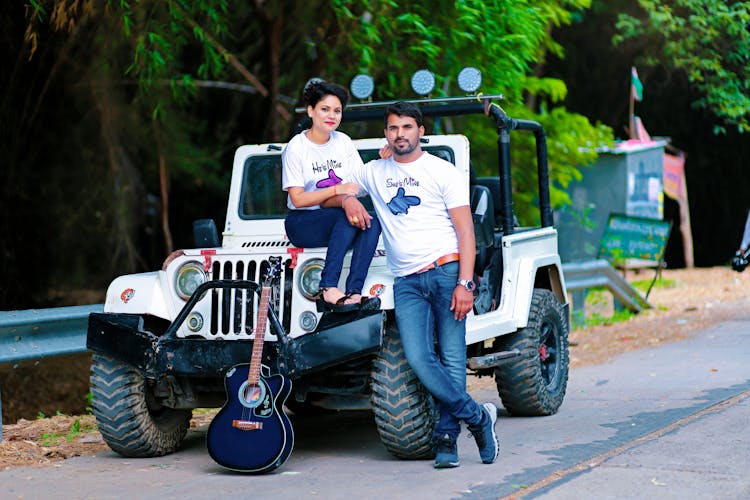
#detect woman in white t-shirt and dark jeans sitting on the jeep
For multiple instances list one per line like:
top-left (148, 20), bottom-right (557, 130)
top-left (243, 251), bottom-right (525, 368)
top-left (281, 81), bottom-right (380, 312)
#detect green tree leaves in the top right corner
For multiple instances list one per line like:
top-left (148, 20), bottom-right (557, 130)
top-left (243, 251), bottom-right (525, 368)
top-left (613, 0), bottom-right (750, 133)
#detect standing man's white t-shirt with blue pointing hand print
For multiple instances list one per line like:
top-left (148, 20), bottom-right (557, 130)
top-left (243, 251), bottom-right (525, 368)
top-left (351, 152), bottom-right (469, 276)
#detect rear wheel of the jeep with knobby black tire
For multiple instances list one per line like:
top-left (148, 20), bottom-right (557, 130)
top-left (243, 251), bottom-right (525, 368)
top-left (494, 288), bottom-right (570, 416)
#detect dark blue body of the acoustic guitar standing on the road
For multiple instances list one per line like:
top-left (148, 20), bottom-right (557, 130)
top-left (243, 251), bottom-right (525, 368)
top-left (206, 364), bottom-right (294, 473)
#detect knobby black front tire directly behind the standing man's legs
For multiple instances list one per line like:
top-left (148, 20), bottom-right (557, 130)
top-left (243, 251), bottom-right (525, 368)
top-left (370, 328), bottom-right (438, 460)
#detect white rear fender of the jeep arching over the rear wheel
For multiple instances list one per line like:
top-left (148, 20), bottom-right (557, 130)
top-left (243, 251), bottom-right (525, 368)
top-left (513, 255), bottom-right (567, 328)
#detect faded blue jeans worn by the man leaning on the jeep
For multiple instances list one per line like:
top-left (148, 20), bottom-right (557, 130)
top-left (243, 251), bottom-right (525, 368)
top-left (393, 262), bottom-right (482, 438)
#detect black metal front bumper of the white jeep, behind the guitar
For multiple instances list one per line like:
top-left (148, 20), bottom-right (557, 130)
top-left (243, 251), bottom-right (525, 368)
top-left (86, 311), bottom-right (385, 380)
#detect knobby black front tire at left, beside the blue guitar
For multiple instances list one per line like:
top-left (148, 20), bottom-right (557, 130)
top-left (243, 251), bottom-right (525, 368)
top-left (90, 354), bottom-right (192, 457)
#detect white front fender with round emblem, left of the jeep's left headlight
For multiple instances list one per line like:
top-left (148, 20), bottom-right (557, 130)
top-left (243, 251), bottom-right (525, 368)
top-left (104, 271), bottom-right (171, 320)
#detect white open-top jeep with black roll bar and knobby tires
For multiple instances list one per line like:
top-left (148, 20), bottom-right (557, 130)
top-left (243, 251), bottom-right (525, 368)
top-left (87, 96), bottom-right (569, 458)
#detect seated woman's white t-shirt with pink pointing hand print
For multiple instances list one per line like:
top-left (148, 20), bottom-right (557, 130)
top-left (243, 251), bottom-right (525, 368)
top-left (281, 130), bottom-right (362, 210)
